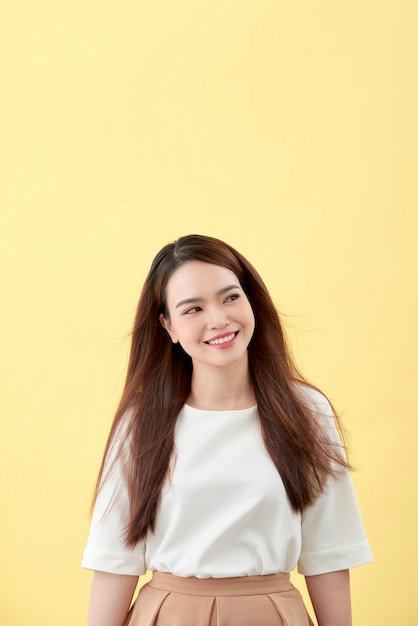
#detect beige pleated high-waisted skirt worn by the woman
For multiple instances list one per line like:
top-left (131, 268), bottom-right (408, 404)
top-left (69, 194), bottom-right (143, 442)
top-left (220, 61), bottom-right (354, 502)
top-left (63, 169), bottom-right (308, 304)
top-left (124, 572), bottom-right (313, 626)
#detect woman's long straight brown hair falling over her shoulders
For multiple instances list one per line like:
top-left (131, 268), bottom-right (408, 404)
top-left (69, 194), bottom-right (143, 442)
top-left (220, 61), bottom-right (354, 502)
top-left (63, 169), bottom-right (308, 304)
top-left (95, 235), bottom-right (347, 547)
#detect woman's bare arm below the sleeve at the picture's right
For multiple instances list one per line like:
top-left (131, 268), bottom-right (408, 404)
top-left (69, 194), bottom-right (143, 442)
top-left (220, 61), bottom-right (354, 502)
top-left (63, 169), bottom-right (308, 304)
top-left (305, 569), bottom-right (352, 626)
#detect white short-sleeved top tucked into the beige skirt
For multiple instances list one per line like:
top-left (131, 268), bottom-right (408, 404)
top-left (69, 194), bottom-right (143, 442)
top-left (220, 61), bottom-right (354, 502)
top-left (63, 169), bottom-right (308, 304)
top-left (82, 388), bottom-right (372, 578)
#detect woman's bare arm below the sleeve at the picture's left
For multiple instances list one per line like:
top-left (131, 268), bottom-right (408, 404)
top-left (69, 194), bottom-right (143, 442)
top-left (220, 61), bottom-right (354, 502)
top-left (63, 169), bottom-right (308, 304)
top-left (87, 572), bottom-right (138, 626)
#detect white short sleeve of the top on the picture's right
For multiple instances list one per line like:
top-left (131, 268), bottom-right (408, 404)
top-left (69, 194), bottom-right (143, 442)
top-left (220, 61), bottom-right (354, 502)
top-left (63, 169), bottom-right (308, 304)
top-left (298, 392), bottom-right (373, 576)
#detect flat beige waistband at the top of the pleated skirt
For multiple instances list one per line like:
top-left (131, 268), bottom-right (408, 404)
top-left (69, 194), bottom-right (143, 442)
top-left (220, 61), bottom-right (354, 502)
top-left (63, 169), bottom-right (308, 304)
top-left (148, 572), bottom-right (293, 596)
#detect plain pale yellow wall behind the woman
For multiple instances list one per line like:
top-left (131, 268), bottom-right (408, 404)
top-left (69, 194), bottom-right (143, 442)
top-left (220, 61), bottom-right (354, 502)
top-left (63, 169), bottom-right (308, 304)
top-left (0, 0), bottom-right (418, 626)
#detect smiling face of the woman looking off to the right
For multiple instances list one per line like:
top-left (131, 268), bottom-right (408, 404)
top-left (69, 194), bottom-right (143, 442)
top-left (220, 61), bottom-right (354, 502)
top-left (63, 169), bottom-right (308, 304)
top-left (160, 261), bottom-right (255, 368)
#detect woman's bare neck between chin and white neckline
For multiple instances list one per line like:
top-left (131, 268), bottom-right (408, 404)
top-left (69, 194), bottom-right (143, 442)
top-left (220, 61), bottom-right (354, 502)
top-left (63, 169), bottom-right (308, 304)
top-left (187, 366), bottom-right (256, 411)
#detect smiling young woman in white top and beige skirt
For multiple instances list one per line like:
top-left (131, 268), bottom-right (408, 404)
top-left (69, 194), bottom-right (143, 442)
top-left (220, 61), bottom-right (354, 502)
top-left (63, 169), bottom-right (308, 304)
top-left (83, 235), bottom-right (371, 626)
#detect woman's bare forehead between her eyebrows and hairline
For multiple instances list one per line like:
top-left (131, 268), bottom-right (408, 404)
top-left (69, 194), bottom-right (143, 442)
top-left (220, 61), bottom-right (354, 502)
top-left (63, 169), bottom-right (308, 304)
top-left (167, 261), bottom-right (240, 302)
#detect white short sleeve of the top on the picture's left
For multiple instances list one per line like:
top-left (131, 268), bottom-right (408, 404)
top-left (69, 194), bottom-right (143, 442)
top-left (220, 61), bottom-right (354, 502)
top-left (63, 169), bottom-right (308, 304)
top-left (81, 426), bottom-right (146, 576)
